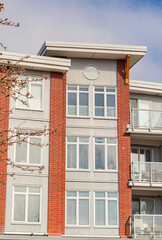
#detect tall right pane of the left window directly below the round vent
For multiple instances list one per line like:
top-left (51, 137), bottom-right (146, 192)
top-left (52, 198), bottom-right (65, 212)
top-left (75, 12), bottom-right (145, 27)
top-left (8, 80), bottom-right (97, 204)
top-left (79, 93), bottom-right (89, 116)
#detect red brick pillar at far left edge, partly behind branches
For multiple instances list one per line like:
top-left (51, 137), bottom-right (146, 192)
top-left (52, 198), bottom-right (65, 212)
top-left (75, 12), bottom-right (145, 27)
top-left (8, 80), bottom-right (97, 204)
top-left (0, 89), bottom-right (9, 234)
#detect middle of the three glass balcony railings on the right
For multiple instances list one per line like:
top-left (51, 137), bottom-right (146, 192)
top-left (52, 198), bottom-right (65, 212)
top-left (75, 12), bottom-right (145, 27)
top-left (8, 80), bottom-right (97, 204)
top-left (131, 162), bottom-right (162, 183)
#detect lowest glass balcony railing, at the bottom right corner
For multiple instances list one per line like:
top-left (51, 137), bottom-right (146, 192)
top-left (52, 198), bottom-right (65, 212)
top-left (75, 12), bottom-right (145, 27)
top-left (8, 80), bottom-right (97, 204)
top-left (129, 214), bottom-right (162, 239)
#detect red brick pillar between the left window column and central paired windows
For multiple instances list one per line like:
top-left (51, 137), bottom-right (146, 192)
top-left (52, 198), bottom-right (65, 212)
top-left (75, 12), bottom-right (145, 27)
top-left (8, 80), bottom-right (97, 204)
top-left (48, 73), bottom-right (66, 235)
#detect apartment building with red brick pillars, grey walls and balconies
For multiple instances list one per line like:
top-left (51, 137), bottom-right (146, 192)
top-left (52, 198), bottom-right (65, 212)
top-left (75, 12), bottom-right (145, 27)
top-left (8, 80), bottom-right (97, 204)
top-left (0, 42), bottom-right (162, 239)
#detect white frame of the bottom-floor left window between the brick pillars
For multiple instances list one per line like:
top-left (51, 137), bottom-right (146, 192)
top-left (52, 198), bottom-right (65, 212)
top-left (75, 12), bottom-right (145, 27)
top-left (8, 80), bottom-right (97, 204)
top-left (65, 190), bottom-right (90, 228)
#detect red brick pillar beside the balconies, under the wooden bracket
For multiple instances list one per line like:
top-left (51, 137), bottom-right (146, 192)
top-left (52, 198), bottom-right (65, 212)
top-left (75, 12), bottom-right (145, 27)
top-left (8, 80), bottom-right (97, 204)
top-left (117, 60), bottom-right (132, 237)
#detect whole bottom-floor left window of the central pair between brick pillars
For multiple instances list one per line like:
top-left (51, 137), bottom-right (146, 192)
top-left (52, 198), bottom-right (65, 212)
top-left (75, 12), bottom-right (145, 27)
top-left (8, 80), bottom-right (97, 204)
top-left (66, 191), bottom-right (89, 226)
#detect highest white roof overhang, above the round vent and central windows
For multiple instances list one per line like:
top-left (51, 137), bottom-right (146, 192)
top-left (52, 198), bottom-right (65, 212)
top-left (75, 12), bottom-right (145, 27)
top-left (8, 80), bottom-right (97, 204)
top-left (38, 41), bottom-right (147, 68)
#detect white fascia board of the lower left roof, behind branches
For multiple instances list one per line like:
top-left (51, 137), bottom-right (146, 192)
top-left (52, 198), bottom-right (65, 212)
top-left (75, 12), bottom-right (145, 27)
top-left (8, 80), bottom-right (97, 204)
top-left (0, 52), bottom-right (71, 73)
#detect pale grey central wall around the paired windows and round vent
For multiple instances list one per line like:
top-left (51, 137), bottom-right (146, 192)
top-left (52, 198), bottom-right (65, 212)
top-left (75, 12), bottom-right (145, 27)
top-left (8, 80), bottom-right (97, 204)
top-left (65, 59), bottom-right (119, 236)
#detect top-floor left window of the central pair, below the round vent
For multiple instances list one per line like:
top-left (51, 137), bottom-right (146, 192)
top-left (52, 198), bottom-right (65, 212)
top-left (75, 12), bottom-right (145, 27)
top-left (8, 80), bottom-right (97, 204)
top-left (67, 86), bottom-right (89, 116)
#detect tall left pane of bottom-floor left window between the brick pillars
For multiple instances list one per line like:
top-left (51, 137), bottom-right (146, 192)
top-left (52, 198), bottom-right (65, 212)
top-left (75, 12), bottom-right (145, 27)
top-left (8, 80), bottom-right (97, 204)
top-left (66, 199), bottom-right (76, 225)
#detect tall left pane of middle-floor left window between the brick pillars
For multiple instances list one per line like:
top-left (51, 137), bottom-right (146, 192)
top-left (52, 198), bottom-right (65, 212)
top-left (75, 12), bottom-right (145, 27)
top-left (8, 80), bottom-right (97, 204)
top-left (67, 144), bottom-right (77, 168)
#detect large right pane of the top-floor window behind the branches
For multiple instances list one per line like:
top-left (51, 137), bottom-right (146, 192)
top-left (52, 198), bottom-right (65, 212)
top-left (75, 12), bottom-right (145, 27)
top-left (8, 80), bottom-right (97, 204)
top-left (30, 83), bottom-right (42, 109)
